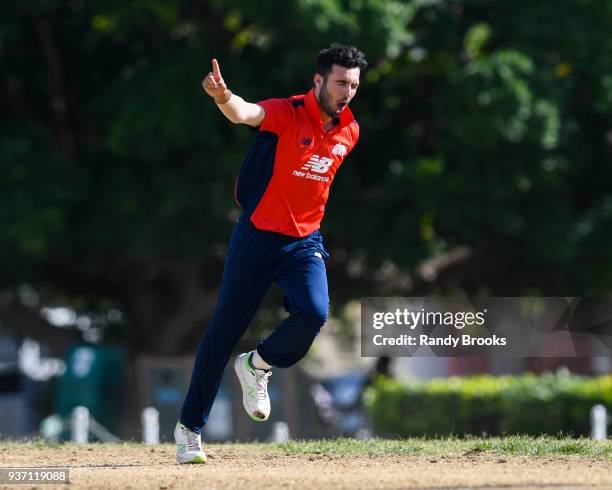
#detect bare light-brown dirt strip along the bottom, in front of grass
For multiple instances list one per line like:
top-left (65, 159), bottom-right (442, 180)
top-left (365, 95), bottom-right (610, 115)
top-left (0, 444), bottom-right (612, 490)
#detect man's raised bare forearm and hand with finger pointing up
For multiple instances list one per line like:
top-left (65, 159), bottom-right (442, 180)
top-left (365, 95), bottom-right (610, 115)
top-left (202, 58), bottom-right (266, 127)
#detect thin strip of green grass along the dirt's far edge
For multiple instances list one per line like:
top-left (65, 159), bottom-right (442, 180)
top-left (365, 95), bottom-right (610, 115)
top-left (5, 436), bottom-right (612, 461)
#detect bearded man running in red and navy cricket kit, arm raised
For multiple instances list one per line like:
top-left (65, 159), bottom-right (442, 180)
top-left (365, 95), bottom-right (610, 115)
top-left (174, 44), bottom-right (367, 463)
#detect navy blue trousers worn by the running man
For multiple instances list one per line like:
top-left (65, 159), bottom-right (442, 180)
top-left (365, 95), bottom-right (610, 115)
top-left (181, 215), bottom-right (329, 432)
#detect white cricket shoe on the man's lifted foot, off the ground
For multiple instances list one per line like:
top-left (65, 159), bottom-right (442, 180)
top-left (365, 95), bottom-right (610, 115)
top-left (234, 351), bottom-right (272, 422)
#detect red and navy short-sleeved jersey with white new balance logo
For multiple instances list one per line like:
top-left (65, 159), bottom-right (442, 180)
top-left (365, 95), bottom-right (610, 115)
top-left (236, 90), bottom-right (359, 237)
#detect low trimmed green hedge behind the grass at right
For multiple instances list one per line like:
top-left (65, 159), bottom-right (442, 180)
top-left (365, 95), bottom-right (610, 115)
top-left (367, 374), bottom-right (612, 437)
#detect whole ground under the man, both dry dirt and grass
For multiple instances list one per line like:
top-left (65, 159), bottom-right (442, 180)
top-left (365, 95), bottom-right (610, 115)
top-left (0, 437), bottom-right (612, 490)
